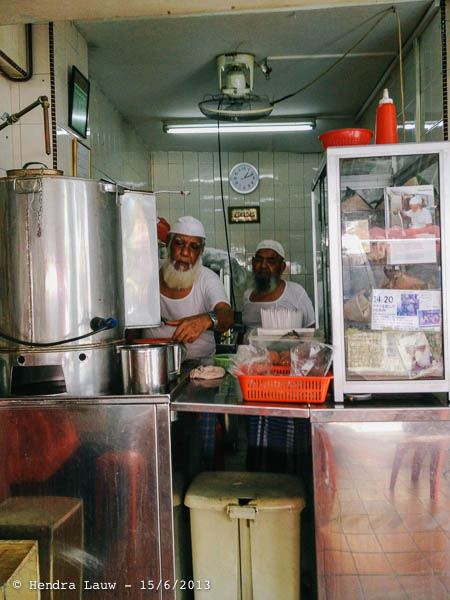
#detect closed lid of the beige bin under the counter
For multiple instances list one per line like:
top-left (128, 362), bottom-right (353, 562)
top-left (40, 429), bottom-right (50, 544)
top-left (184, 471), bottom-right (305, 511)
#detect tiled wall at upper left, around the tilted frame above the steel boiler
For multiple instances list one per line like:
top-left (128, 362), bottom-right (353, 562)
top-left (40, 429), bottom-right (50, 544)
top-left (0, 21), bottom-right (150, 189)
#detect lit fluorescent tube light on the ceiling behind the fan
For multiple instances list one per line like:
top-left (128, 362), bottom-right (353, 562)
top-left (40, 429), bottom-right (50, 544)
top-left (163, 119), bottom-right (316, 135)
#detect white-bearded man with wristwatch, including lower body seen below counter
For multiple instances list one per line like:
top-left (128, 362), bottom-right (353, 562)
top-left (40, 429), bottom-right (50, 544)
top-left (143, 216), bottom-right (234, 475)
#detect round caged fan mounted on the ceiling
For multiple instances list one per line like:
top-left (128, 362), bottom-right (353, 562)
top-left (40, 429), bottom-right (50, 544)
top-left (198, 53), bottom-right (274, 121)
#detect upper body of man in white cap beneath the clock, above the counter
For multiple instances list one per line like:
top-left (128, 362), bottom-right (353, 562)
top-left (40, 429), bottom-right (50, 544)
top-left (242, 240), bottom-right (315, 327)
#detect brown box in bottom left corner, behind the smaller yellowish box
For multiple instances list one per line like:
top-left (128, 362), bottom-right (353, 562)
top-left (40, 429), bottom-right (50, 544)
top-left (0, 496), bottom-right (83, 600)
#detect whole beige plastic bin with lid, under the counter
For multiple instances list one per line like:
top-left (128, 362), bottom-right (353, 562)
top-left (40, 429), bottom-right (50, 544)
top-left (185, 471), bottom-right (305, 600)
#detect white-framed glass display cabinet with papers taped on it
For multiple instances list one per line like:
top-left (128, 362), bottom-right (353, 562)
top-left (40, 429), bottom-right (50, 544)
top-left (312, 142), bottom-right (450, 402)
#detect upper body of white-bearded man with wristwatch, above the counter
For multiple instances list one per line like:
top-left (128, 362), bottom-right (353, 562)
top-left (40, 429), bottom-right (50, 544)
top-left (146, 216), bottom-right (234, 358)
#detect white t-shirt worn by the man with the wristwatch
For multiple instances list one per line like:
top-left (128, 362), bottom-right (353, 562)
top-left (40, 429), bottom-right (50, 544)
top-left (143, 266), bottom-right (229, 358)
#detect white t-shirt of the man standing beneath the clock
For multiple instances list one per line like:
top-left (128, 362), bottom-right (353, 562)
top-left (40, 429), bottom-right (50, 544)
top-left (242, 281), bottom-right (316, 327)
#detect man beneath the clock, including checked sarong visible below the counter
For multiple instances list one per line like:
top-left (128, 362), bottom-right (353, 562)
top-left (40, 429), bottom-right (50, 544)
top-left (242, 240), bottom-right (315, 472)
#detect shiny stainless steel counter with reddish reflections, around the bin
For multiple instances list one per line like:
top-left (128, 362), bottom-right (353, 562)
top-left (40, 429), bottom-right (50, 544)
top-left (5, 375), bottom-right (450, 600)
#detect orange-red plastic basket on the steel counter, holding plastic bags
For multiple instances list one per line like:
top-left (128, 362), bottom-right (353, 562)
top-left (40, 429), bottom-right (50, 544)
top-left (237, 366), bottom-right (333, 404)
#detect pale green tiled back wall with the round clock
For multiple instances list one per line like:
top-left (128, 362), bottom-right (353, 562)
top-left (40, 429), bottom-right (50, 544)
top-left (151, 152), bottom-right (321, 308)
